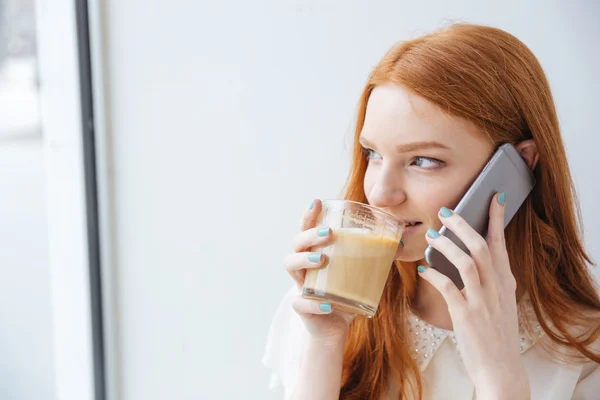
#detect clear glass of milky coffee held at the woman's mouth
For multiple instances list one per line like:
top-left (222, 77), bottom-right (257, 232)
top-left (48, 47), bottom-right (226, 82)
top-left (302, 200), bottom-right (405, 317)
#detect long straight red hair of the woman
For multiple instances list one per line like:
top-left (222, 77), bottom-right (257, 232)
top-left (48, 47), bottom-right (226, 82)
top-left (340, 24), bottom-right (600, 399)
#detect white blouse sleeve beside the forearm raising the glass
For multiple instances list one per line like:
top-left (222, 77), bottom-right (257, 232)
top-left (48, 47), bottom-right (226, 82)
top-left (262, 286), bottom-right (308, 391)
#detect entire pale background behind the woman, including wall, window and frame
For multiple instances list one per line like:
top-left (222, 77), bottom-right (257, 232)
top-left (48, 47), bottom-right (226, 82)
top-left (0, 0), bottom-right (600, 400)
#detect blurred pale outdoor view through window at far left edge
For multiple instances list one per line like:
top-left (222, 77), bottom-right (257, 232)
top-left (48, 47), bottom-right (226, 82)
top-left (0, 0), bottom-right (55, 400)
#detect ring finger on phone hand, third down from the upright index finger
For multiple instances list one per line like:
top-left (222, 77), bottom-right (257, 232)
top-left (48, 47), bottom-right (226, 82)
top-left (425, 228), bottom-right (482, 298)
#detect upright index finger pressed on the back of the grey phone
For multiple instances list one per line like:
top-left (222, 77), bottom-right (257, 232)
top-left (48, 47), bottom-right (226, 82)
top-left (487, 192), bottom-right (514, 288)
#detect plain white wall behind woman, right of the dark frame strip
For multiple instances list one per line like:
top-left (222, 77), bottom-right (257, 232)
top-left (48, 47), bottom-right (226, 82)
top-left (96, 0), bottom-right (600, 400)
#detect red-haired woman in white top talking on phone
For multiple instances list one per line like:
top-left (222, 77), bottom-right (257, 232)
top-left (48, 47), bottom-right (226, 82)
top-left (264, 24), bottom-right (600, 400)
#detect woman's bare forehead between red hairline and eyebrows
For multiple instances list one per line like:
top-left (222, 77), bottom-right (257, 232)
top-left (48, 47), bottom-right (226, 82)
top-left (361, 84), bottom-right (482, 147)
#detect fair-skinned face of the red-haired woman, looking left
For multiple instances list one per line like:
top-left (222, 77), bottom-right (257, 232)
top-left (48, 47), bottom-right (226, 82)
top-left (360, 85), bottom-right (494, 261)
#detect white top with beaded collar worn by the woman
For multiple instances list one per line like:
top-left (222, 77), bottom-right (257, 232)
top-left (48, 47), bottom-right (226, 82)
top-left (263, 286), bottom-right (600, 400)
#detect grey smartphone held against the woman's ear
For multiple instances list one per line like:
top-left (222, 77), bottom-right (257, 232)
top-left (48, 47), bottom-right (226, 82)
top-left (425, 143), bottom-right (535, 290)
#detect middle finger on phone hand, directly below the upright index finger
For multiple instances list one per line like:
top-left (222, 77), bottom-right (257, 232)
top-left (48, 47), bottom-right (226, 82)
top-left (439, 207), bottom-right (496, 286)
